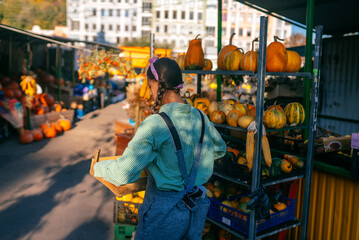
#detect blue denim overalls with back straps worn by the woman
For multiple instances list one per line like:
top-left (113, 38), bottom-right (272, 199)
top-left (135, 111), bottom-right (209, 240)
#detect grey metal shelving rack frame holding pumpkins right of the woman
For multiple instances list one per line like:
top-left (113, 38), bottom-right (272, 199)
top-left (182, 17), bottom-right (323, 240)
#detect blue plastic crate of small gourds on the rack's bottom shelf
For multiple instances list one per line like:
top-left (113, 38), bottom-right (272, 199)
top-left (208, 196), bottom-right (295, 234)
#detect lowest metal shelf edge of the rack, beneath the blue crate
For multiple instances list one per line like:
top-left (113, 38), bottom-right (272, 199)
top-left (207, 217), bottom-right (301, 239)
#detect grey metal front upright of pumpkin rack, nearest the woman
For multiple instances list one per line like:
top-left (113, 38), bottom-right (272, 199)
top-left (249, 16), bottom-right (268, 240)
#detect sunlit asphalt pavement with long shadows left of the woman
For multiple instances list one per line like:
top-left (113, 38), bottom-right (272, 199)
top-left (0, 102), bottom-right (132, 240)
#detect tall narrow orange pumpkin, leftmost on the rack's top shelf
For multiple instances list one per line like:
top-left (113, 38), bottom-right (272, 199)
top-left (184, 34), bottom-right (204, 70)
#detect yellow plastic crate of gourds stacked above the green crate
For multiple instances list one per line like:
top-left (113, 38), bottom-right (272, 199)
top-left (113, 200), bottom-right (142, 226)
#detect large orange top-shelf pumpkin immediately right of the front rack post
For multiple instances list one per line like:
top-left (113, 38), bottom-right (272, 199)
top-left (266, 36), bottom-right (288, 72)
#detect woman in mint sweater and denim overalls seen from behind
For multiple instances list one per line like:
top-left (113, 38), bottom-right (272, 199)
top-left (94, 58), bottom-right (226, 240)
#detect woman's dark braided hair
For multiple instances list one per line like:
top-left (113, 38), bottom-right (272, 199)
top-left (147, 57), bottom-right (183, 113)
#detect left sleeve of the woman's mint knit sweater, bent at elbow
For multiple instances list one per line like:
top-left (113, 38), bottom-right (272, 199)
top-left (94, 119), bottom-right (157, 186)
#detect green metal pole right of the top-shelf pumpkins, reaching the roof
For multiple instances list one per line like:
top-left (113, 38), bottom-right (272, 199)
top-left (303, 0), bottom-right (314, 139)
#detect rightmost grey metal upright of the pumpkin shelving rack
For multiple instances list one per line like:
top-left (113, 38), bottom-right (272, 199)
top-left (301, 26), bottom-right (323, 240)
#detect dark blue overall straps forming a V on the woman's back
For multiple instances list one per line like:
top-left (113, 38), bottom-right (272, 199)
top-left (159, 109), bottom-right (205, 190)
